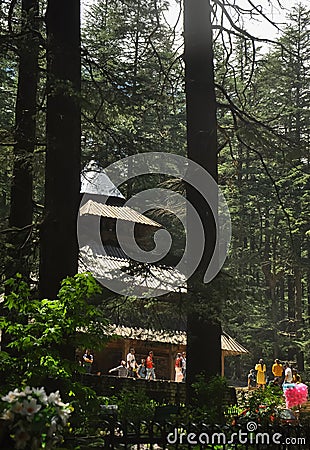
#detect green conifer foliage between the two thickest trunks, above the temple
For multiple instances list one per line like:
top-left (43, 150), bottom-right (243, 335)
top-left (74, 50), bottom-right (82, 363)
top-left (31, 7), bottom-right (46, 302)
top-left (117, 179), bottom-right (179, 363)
top-left (82, 0), bottom-right (185, 167)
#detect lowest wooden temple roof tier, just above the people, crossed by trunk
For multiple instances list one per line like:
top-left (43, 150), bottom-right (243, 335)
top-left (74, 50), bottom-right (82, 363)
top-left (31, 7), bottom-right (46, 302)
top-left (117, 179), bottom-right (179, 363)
top-left (107, 325), bottom-right (249, 356)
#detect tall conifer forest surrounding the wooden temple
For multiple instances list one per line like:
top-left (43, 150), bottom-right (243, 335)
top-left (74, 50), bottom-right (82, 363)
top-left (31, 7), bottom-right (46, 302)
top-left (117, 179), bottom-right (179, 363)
top-left (0, 0), bottom-right (310, 428)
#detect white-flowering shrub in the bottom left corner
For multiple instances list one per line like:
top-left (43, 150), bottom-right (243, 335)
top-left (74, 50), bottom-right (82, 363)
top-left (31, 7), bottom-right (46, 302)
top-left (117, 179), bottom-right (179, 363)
top-left (2, 386), bottom-right (72, 450)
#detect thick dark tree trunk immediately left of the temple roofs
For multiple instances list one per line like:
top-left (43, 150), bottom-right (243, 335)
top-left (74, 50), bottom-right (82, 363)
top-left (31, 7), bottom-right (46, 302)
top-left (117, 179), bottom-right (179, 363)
top-left (40, 0), bottom-right (81, 298)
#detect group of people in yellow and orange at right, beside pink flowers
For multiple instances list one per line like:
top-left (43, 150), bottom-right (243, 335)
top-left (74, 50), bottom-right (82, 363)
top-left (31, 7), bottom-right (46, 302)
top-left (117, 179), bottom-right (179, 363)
top-left (248, 359), bottom-right (301, 389)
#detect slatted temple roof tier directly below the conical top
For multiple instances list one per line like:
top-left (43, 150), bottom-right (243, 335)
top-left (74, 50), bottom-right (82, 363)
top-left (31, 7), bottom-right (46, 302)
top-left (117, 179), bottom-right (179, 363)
top-left (80, 200), bottom-right (162, 228)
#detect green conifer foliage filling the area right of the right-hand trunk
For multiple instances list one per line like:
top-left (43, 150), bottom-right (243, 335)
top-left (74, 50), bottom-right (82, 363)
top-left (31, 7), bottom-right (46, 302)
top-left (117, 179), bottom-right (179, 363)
top-left (217, 5), bottom-right (310, 378)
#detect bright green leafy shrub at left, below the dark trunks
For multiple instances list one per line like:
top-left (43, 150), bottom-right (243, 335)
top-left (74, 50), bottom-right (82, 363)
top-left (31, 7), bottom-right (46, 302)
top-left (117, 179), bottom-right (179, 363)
top-left (0, 274), bottom-right (106, 387)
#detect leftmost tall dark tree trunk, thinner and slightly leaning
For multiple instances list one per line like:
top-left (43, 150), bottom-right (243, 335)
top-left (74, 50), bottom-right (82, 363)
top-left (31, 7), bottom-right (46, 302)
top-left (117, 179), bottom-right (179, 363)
top-left (7, 0), bottom-right (39, 277)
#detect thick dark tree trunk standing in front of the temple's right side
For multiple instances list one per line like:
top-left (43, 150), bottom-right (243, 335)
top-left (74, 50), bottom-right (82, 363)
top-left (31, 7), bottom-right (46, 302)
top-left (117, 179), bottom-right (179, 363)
top-left (184, 0), bottom-right (221, 399)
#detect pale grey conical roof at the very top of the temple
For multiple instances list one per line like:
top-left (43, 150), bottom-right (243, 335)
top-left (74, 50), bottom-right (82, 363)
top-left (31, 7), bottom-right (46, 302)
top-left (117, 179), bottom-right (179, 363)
top-left (81, 161), bottom-right (125, 199)
